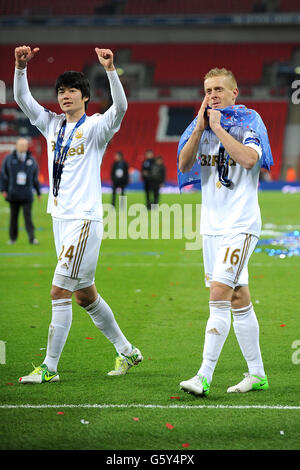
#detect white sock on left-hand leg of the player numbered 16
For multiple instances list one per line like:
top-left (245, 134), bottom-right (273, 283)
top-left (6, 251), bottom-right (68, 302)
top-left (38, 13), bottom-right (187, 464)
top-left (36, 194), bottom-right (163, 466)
top-left (198, 300), bottom-right (231, 383)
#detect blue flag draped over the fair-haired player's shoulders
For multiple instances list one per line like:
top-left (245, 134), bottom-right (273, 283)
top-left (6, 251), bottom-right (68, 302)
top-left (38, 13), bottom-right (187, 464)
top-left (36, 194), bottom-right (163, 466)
top-left (177, 105), bottom-right (273, 190)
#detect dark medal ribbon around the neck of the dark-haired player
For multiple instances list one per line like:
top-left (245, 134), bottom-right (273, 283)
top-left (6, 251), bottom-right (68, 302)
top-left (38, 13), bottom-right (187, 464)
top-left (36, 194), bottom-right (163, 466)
top-left (53, 114), bottom-right (86, 197)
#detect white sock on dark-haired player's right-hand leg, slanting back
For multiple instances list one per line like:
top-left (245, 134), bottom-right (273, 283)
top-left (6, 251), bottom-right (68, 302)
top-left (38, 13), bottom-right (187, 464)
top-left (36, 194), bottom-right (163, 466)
top-left (85, 294), bottom-right (132, 355)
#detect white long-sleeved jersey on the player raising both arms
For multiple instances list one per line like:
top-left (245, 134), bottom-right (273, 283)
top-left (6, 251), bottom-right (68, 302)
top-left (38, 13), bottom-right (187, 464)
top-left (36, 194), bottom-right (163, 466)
top-left (14, 70), bottom-right (127, 220)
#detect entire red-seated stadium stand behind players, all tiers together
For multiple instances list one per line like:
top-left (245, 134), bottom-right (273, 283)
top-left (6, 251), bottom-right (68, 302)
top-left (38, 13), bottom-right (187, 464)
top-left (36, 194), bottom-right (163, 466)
top-left (0, 0), bottom-right (300, 183)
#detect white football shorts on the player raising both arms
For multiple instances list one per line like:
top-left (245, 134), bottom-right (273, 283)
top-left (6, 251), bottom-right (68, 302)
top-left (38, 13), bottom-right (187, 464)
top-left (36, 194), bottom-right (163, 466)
top-left (52, 218), bottom-right (103, 292)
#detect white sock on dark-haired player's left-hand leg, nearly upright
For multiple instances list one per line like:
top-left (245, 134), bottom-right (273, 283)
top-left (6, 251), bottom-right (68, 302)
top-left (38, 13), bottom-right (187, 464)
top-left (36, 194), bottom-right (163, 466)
top-left (43, 299), bottom-right (72, 372)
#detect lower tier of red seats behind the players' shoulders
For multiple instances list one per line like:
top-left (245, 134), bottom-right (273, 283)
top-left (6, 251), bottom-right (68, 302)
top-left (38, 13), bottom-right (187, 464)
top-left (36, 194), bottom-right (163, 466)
top-left (0, 101), bottom-right (288, 183)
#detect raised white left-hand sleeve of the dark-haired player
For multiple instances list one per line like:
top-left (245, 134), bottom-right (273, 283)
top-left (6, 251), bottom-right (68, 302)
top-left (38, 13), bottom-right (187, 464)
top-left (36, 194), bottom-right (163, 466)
top-left (14, 68), bottom-right (53, 137)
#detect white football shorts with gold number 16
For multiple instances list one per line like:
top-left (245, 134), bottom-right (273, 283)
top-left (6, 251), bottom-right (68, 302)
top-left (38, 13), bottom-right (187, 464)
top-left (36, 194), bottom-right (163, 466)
top-left (203, 233), bottom-right (258, 289)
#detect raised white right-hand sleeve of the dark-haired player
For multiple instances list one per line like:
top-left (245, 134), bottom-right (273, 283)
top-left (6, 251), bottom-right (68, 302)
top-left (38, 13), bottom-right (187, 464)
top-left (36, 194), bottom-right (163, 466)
top-left (99, 70), bottom-right (127, 142)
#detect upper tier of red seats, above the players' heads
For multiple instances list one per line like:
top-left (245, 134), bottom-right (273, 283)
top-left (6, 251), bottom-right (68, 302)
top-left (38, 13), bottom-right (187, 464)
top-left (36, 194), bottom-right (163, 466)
top-left (0, 43), bottom-right (297, 87)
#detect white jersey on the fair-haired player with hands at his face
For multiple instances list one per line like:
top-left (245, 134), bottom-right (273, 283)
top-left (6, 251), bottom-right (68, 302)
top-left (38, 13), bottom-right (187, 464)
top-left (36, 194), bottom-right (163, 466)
top-left (197, 127), bottom-right (262, 237)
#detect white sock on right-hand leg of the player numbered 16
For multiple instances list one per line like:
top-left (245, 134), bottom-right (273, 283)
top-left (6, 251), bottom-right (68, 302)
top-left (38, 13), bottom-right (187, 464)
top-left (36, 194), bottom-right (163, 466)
top-left (232, 304), bottom-right (265, 377)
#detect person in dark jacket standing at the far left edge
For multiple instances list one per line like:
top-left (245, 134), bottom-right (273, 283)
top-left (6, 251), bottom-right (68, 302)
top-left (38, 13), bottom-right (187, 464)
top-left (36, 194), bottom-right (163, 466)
top-left (0, 137), bottom-right (41, 245)
